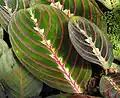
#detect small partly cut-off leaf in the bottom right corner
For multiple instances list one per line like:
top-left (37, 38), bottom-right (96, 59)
top-left (100, 73), bottom-right (120, 98)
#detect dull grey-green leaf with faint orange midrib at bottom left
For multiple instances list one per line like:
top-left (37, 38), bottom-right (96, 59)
top-left (0, 50), bottom-right (43, 98)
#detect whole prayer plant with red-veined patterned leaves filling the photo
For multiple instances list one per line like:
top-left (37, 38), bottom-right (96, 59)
top-left (0, 0), bottom-right (120, 98)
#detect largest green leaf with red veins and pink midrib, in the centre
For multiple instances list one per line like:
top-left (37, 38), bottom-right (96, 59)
top-left (9, 4), bottom-right (92, 93)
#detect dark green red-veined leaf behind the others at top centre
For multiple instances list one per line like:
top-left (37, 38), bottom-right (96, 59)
top-left (31, 0), bottom-right (106, 30)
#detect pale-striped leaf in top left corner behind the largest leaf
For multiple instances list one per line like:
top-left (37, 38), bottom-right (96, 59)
top-left (0, 0), bottom-right (30, 31)
